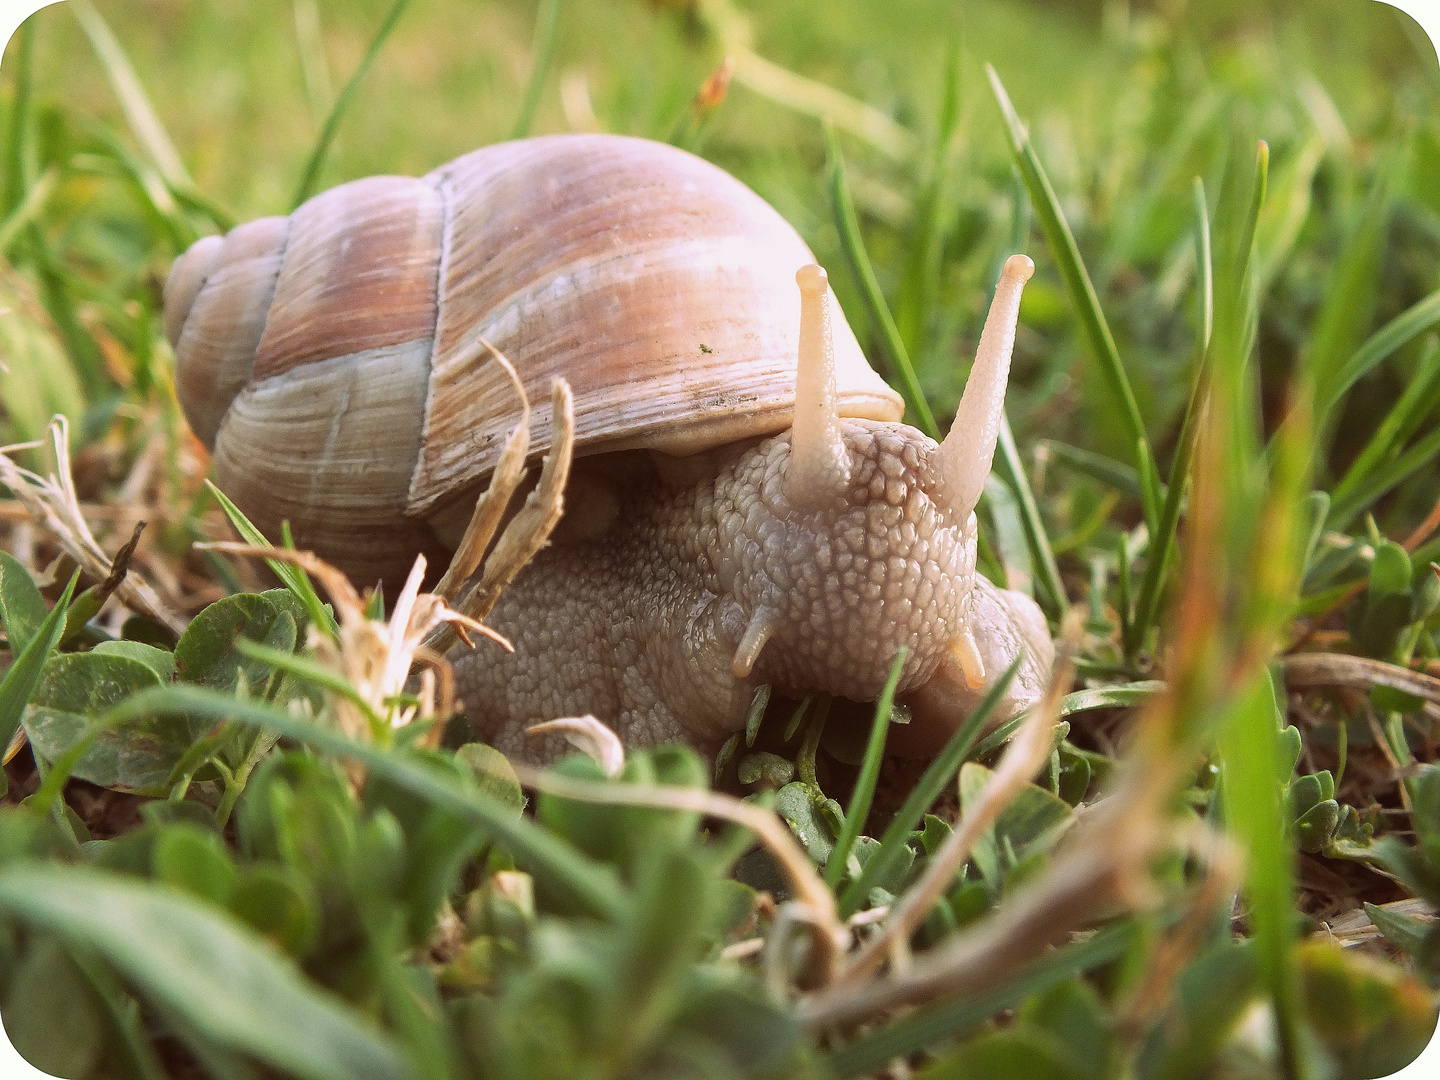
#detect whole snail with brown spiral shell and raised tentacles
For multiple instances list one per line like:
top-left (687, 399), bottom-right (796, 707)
top-left (164, 135), bottom-right (1054, 757)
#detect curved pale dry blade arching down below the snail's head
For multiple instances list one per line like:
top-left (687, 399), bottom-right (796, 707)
top-left (514, 763), bottom-right (847, 985)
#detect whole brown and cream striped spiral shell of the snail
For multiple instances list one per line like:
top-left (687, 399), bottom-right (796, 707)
top-left (166, 135), bottom-right (903, 593)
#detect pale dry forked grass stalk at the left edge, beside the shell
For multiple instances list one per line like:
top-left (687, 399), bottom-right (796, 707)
top-left (0, 416), bottom-right (186, 636)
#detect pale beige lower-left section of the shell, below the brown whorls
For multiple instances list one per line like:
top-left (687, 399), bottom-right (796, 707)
top-left (215, 337), bottom-right (444, 586)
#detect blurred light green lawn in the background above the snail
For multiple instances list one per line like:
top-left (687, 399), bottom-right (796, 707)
top-left (0, 0), bottom-right (1440, 532)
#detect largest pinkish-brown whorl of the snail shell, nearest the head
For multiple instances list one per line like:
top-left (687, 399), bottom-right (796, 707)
top-left (409, 135), bottom-right (901, 514)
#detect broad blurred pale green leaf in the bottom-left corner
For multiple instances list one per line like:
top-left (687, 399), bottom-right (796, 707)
top-left (0, 864), bottom-right (413, 1080)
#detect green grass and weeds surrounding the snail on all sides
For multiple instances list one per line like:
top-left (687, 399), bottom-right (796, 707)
top-left (0, 0), bottom-right (1440, 1080)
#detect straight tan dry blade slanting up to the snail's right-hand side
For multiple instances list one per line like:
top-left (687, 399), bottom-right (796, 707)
top-left (838, 642), bottom-right (1074, 985)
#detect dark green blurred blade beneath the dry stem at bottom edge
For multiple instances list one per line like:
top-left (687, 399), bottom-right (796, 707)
top-left (825, 922), bottom-right (1136, 1080)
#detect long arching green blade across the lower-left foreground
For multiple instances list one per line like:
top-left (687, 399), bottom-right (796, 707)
top-left (96, 685), bottom-right (625, 922)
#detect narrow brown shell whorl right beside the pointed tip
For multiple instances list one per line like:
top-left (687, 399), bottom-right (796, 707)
top-left (166, 217), bottom-right (289, 446)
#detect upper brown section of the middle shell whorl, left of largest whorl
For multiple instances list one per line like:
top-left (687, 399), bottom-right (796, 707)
top-left (255, 176), bottom-right (441, 380)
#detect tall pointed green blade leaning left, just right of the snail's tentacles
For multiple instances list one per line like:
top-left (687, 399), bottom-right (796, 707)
top-left (985, 63), bottom-right (1161, 531)
